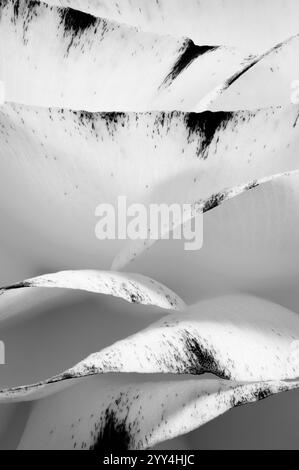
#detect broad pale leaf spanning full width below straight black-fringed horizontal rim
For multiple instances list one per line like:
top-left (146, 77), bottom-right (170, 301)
top-left (0, 104), bottom-right (299, 278)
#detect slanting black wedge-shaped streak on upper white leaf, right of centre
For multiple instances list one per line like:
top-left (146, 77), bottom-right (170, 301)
top-left (160, 39), bottom-right (218, 88)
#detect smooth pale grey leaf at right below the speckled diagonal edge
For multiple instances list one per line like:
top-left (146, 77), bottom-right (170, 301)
top-left (131, 172), bottom-right (299, 304)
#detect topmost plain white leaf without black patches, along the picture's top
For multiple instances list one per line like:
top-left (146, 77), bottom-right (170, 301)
top-left (47, 0), bottom-right (299, 53)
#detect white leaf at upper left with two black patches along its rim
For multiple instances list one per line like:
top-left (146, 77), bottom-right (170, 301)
top-left (0, 0), bottom-right (251, 111)
